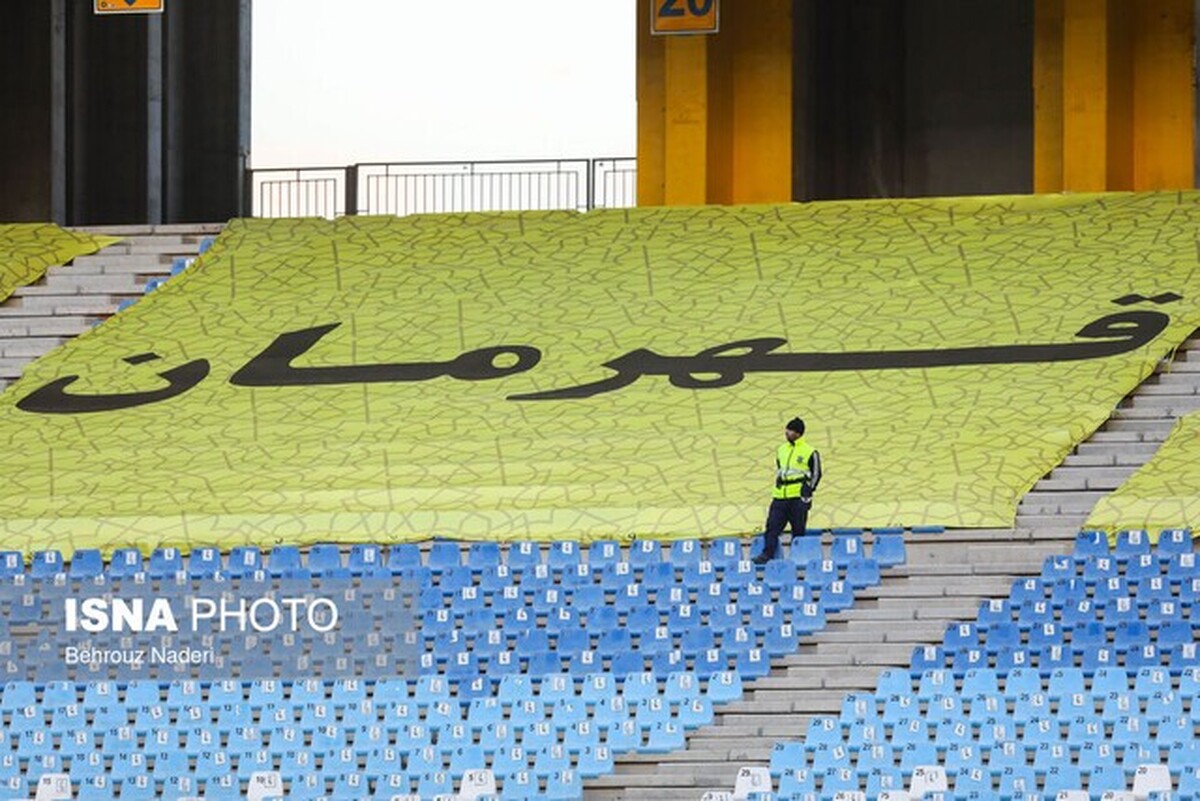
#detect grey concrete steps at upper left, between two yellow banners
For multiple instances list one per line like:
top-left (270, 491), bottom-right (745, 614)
top-left (0, 224), bottom-right (222, 390)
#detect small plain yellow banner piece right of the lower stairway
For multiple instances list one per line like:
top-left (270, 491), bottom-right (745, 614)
top-left (1087, 412), bottom-right (1200, 542)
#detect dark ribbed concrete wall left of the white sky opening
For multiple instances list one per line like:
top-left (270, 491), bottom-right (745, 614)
top-left (0, 0), bottom-right (250, 224)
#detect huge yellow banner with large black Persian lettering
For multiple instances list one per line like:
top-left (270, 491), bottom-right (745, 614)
top-left (0, 192), bottom-right (1200, 549)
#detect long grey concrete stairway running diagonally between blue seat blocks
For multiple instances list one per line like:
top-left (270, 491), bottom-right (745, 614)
top-left (584, 332), bottom-right (1200, 801)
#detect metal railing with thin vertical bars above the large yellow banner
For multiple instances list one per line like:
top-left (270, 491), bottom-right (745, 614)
top-left (246, 158), bottom-right (637, 218)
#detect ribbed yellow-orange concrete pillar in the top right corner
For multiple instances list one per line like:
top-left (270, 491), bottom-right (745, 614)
top-left (1033, 0), bottom-right (1195, 192)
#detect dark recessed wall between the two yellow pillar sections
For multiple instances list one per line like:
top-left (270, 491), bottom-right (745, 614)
top-left (793, 0), bottom-right (1033, 199)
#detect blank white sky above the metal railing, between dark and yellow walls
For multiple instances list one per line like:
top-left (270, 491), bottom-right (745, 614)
top-left (251, 0), bottom-right (637, 168)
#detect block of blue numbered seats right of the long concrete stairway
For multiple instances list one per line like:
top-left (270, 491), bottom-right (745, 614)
top-left (766, 529), bottom-right (1200, 799)
